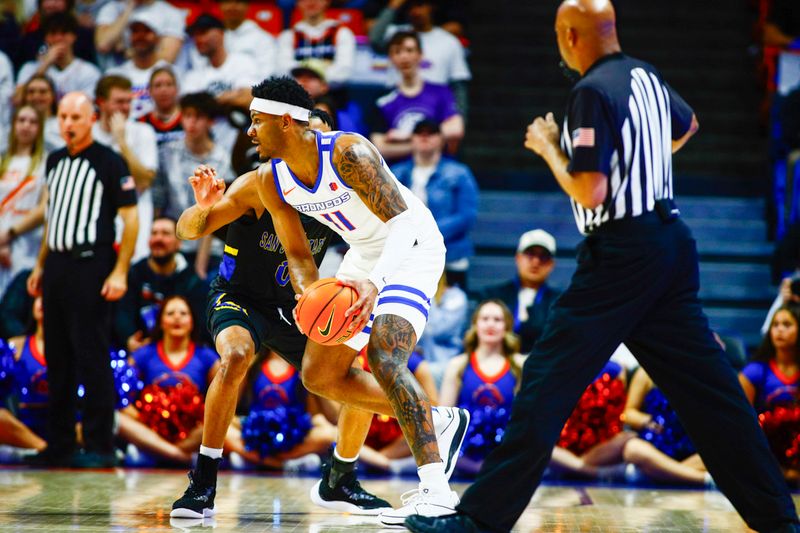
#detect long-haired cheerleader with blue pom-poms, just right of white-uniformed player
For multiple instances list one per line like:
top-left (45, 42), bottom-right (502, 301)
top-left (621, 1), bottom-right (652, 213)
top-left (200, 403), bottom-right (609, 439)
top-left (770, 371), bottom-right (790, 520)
top-left (440, 299), bottom-right (525, 473)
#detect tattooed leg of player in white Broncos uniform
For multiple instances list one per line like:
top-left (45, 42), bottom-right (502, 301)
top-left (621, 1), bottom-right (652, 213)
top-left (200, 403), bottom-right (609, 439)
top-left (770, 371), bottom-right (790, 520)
top-left (367, 315), bottom-right (442, 466)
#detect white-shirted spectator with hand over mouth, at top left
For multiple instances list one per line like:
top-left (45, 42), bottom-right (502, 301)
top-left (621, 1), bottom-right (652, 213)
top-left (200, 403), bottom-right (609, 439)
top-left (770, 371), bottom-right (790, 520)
top-left (16, 13), bottom-right (101, 101)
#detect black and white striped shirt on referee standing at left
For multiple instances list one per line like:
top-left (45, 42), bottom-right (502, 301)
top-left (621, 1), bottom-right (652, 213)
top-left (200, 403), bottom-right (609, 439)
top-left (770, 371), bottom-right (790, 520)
top-left (46, 142), bottom-right (136, 252)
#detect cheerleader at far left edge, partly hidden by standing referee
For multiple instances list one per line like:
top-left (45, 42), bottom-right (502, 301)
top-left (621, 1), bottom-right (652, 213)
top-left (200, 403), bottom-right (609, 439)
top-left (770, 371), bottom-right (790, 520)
top-left (0, 297), bottom-right (49, 452)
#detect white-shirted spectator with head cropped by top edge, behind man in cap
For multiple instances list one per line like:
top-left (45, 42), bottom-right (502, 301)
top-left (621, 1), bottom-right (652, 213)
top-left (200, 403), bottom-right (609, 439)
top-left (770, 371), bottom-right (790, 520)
top-left (95, 0), bottom-right (186, 63)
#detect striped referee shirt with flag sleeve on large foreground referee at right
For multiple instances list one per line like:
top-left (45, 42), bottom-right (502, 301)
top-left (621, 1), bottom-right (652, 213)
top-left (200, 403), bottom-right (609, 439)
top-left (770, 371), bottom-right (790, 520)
top-left (561, 53), bottom-right (693, 233)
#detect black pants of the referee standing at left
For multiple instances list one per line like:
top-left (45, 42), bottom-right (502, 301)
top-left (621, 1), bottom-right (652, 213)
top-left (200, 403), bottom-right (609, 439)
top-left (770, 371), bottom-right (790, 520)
top-left (42, 248), bottom-right (116, 456)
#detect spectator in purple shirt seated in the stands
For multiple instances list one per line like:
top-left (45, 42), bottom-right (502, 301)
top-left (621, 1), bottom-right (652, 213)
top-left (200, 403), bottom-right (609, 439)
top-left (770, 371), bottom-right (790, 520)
top-left (370, 31), bottom-right (464, 160)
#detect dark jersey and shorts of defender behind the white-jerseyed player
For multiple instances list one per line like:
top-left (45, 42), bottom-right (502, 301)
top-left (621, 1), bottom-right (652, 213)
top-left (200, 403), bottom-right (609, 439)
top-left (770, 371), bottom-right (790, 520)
top-left (207, 210), bottom-right (331, 369)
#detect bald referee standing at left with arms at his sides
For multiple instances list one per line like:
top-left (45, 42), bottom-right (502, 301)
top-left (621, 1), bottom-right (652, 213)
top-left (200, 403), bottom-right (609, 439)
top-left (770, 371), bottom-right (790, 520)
top-left (28, 93), bottom-right (138, 467)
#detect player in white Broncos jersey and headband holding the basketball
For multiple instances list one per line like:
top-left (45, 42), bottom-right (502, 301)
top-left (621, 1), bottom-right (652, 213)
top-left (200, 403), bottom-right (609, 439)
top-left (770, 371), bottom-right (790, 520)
top-left (179, 77), bottom-right (469, 526)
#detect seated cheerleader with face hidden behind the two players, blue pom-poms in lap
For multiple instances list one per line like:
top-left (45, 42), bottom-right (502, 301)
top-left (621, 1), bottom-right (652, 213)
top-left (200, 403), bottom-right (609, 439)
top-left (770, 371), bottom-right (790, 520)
top-left (225, 351), bottom-right (336, 470)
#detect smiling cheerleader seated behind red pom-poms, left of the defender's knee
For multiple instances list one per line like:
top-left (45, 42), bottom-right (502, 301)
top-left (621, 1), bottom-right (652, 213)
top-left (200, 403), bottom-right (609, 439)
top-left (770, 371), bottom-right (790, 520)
top-left (118, 296), bottom-right (220, 464)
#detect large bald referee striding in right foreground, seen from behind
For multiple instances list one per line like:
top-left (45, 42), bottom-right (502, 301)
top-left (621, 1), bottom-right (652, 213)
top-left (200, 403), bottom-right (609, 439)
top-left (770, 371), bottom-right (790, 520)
top-left (406, 0), bottom-right (800, 533)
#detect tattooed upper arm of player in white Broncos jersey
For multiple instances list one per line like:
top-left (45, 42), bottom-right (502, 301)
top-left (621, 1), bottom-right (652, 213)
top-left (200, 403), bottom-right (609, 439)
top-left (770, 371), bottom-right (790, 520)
top-left (333, 135), bottom-right (408, 222)
